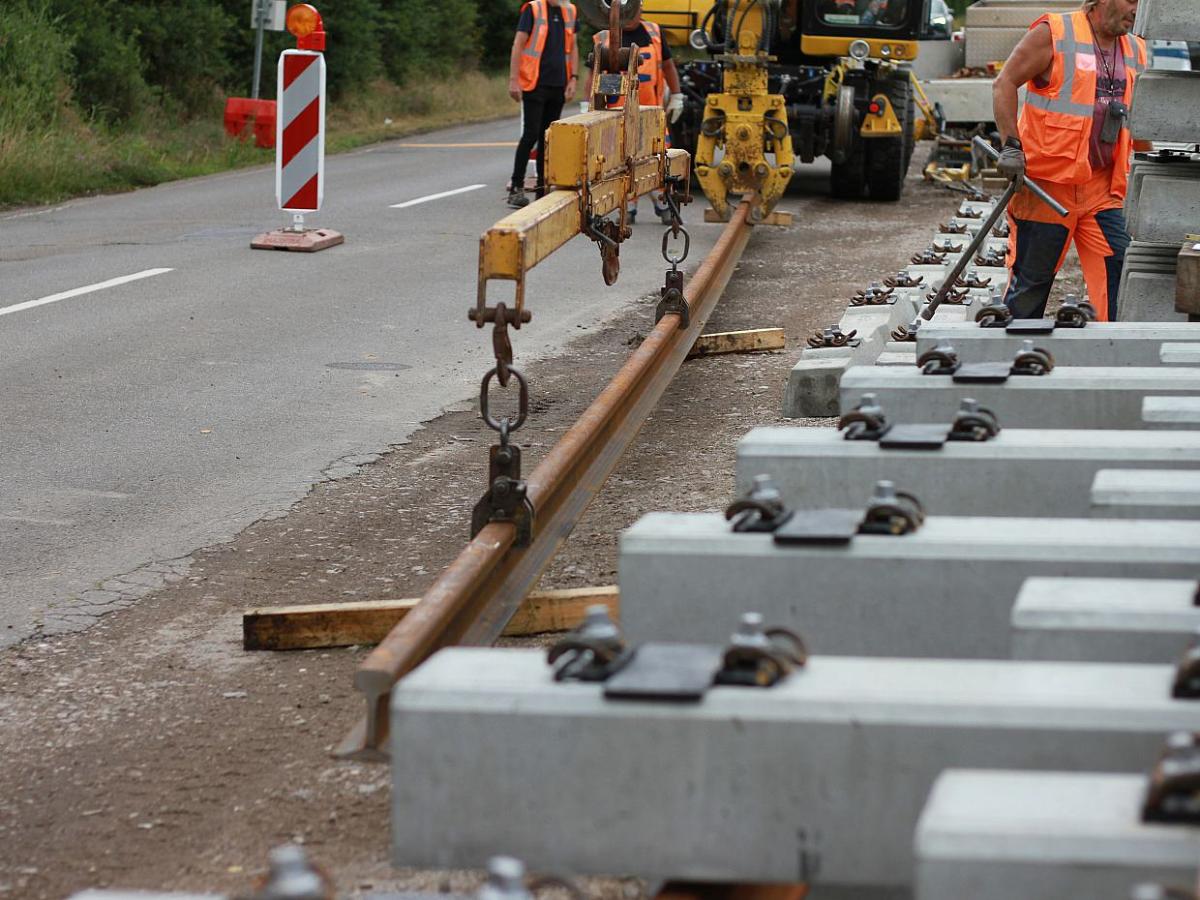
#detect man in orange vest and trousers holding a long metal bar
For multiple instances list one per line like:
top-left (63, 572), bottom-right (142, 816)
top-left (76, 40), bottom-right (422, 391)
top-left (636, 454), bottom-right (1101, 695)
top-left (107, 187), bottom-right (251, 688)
top-left (992, 0), bottom-right (1146, 322)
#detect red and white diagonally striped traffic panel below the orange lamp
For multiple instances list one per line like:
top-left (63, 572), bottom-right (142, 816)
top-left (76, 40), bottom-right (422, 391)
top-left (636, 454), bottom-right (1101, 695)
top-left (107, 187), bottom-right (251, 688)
top-left (275, 50), bottom-right (325, 212)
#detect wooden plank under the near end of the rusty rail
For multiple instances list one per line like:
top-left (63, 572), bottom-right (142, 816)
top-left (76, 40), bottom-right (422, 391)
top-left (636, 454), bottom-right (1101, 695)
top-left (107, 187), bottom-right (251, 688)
top-left (241, 584), bottom-right (620, 650)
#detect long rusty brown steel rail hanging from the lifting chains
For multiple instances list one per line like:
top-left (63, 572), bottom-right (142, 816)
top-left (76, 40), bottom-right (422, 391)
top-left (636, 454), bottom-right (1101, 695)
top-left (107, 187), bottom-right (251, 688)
top-left (335, 200), bottom-right (751, 761)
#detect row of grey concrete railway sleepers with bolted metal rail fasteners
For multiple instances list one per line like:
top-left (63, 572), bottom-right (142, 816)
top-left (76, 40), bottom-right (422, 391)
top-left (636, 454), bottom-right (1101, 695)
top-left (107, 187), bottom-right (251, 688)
top-left (376, 180), bottom-right (1200, 900)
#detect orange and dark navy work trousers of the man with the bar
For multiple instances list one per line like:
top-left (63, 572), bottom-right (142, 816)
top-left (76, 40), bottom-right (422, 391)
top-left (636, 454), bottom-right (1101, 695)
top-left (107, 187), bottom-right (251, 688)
top-left (1004, 169), bottom-right (1129, 322)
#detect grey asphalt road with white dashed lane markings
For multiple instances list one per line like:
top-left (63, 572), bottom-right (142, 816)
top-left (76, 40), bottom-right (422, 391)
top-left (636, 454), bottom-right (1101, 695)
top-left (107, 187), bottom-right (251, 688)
top-left (0, 121), bottom-right (720, 646)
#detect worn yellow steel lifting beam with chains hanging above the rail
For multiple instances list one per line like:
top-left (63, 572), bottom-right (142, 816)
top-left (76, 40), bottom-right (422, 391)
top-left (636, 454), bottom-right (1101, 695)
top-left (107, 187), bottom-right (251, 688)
top-left (470, 49), bottom-right (691, 328)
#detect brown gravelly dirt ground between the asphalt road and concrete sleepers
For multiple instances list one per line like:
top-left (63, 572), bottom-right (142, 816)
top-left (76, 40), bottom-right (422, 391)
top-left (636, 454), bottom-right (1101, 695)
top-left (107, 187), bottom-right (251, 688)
top-left (0, 162), bottom-right (1078, 899)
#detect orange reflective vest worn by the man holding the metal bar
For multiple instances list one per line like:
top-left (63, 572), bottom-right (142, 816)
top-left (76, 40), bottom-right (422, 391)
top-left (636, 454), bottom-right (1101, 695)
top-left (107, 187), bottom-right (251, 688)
top-left (1018, 11), bottom-right (1146, 197)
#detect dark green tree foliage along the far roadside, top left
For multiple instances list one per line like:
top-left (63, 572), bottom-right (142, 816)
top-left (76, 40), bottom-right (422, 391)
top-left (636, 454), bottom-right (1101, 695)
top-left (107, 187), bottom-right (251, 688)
top-left (0, 0), bottom-right (532, 122)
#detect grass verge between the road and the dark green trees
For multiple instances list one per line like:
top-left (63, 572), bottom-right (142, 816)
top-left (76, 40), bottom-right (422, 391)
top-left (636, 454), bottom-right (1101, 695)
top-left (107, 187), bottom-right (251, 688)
top-left (0, 72), bottom-right (517, 208)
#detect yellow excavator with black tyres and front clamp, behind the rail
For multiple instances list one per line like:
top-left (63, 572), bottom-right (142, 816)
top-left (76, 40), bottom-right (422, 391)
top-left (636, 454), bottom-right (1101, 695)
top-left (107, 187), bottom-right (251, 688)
top-left (590, 0), bottom-right (937, 218)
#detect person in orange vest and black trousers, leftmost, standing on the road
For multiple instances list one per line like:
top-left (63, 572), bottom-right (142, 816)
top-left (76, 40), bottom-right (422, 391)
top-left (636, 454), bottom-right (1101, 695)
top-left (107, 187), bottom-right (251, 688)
top-left (509, 0), bottom-right (580, 209)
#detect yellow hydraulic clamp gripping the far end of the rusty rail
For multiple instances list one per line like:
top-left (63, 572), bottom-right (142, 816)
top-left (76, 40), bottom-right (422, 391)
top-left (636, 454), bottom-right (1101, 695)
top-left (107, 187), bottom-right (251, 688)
top-left (696, 0), bottom-right (792, 222)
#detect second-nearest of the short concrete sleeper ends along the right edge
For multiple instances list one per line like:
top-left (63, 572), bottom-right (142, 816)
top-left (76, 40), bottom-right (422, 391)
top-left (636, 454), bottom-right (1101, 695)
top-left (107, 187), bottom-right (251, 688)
top-left (1013, 577), bottom-right (1200, 662)
